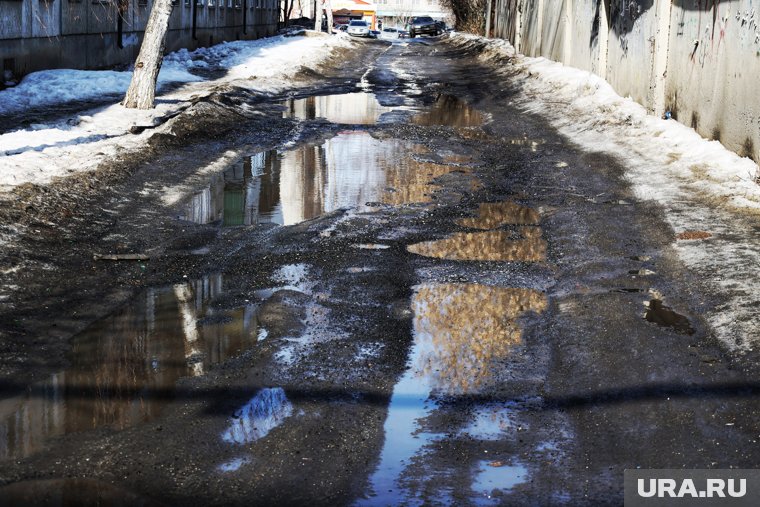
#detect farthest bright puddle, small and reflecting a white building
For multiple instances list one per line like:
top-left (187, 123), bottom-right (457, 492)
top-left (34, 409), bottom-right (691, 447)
top-left (283, 92), bottom-right (393, 125)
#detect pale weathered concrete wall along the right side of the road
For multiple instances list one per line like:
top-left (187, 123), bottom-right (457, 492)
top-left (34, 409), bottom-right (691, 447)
top-left (495, 0), bottom-right (760, 161)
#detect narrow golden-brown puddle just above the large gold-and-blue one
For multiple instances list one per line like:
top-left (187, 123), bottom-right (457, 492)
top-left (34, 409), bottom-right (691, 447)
top-left (407, 227), bottom-right (547, 262)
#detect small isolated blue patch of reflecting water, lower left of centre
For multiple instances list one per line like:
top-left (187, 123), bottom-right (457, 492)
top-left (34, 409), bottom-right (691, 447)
top-left (222, 387), bottom-right (293, 444)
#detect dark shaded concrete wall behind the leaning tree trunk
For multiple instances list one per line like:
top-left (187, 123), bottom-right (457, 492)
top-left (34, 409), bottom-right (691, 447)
top-left (0, 0), bottom-right (279, 77)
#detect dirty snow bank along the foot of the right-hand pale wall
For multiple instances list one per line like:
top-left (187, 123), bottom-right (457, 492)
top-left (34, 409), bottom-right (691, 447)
top-left (453, 30), bottom-right (760, 351)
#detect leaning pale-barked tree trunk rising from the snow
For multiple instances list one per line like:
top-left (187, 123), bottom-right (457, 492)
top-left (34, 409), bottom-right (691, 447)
top-left (123, 0), bottom-right (174, 109)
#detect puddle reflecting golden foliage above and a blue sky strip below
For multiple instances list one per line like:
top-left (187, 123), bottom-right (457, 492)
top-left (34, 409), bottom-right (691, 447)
top-left (359, 284), bottom-right (547, 505)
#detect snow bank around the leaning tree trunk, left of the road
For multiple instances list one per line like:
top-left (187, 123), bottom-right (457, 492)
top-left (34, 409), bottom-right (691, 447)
top-left (0, 32), bottom-right (349, 191)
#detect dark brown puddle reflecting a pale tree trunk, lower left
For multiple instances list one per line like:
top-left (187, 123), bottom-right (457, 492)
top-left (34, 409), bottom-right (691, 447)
top-left (0, 274), bottom-right (258, 460)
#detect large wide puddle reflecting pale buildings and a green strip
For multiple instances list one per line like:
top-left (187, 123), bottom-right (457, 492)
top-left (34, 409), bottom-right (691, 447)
top-left (181, 131), bottom-right (464, 226)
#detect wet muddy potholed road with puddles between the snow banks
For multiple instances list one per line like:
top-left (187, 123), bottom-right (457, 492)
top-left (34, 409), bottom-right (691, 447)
top-left (0, 35), bottom-right (760, 506)
